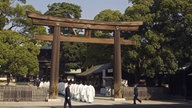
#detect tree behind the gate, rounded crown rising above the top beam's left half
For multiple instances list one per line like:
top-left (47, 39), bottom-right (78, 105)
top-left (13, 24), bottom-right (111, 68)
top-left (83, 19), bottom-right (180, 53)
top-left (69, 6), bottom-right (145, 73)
top-left (45, 2), bottom-right (86, 72)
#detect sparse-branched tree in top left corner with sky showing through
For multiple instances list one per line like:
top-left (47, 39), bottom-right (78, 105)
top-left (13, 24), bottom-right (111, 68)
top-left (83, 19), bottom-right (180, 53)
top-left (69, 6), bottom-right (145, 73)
top-left (0, 0), bottom-right (46, 37)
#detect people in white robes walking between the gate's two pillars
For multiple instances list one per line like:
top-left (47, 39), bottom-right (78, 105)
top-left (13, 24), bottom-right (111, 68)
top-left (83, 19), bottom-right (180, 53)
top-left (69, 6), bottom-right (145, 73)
top-left (58, 82), bottom-right (95, 103)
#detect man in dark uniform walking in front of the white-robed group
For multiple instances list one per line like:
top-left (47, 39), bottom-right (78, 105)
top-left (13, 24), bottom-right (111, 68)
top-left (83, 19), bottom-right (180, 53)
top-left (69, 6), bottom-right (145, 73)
top-left (64, 82), bottom-right (72, 108)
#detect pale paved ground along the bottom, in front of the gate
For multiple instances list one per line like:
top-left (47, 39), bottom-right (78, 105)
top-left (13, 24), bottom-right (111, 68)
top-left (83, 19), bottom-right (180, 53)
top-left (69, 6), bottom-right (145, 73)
top-left (0, 97), bottom-right (192, 108)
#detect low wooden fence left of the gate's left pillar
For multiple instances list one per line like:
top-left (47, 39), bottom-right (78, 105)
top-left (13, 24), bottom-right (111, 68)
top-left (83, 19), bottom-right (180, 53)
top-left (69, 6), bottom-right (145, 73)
top-left (0, 86), bottom-right (48, 101)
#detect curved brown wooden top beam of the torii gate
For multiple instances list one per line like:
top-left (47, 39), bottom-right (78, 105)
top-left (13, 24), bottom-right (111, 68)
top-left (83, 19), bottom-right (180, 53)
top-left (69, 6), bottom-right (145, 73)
top-left (27, 12), bottom-right (143, 31)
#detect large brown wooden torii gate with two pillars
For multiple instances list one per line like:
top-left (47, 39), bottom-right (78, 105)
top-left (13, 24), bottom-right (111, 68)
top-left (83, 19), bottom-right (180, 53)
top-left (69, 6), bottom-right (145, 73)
top-left (27, 12), bottom-right (143, 99)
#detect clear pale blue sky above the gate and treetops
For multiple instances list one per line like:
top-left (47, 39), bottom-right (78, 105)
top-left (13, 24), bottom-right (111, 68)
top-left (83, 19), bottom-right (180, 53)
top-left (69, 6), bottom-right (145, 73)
top-left (26, 0), bottom-right (131, 20)
